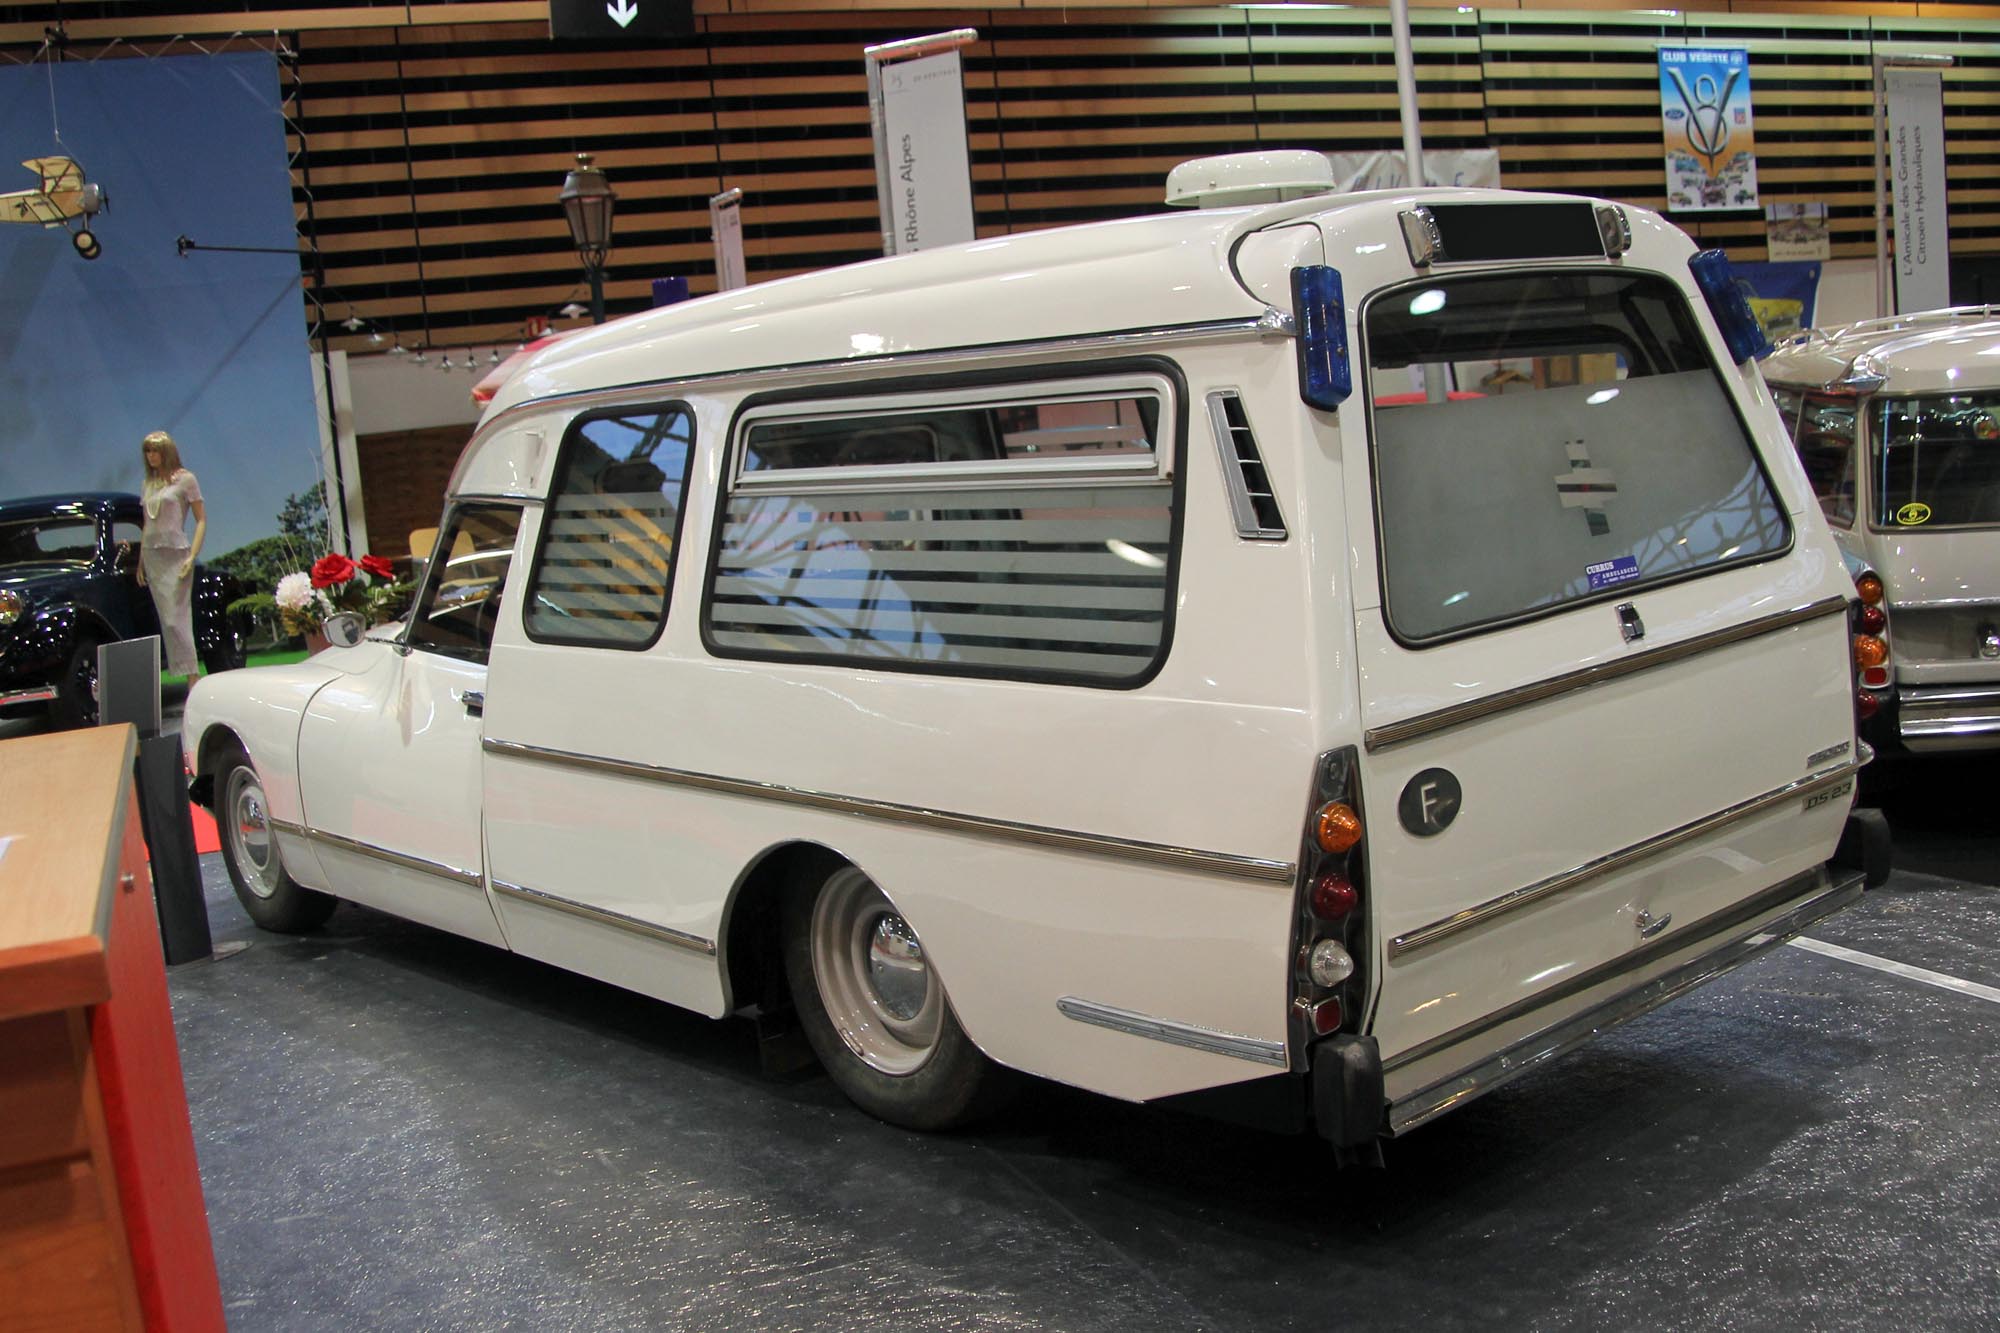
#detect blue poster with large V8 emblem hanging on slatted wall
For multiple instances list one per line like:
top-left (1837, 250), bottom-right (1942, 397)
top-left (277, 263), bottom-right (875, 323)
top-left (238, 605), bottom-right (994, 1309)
top-left (1660, 46), bottom-right (1756, 212)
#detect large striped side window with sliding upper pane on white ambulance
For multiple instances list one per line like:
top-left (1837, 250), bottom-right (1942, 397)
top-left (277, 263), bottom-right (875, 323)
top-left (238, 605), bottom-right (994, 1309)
top-left (704, 376), bottom-right (1174, 685)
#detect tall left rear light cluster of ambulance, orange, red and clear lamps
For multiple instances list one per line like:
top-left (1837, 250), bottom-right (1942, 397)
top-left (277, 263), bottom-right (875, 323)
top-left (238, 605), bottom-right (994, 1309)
top-left (1292, 747), bottom-right (1368, 1051)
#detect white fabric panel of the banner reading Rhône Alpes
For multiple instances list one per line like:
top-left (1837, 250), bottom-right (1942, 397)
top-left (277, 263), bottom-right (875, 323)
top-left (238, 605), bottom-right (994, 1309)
top-left (876, 50), bottom-right (972, 254)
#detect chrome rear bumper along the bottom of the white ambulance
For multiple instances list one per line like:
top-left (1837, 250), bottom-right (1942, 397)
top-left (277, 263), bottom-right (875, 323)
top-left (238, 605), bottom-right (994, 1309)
top-left (1382, 867), bottom-right (1864, 1135)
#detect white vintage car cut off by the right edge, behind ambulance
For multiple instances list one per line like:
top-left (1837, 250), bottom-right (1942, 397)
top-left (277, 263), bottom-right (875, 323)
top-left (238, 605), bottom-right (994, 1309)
top-left (1764, 308), bottom-right (2000, 757)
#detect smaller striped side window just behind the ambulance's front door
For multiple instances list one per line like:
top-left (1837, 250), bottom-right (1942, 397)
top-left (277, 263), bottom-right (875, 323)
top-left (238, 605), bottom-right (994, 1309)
top-left (526, 404), bottom-right (694, 648)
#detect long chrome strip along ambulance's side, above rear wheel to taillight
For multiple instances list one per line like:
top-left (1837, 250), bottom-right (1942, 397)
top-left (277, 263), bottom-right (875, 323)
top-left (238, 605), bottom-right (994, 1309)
top-left (482, 737), bottom-right (1298, 885)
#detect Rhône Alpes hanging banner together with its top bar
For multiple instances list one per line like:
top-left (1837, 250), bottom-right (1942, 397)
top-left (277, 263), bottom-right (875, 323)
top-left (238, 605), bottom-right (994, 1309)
top-left (862, 28), bottom-right (980, 254)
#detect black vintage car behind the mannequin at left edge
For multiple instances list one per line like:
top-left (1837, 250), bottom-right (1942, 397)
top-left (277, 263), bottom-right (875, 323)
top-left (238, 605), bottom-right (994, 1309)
top-left (0, 492), bottom-right (242, 727)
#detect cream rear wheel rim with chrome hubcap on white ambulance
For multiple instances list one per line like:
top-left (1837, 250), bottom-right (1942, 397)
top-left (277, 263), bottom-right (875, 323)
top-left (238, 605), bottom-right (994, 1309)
top-left (812, 867), bottom-right (944, 1075)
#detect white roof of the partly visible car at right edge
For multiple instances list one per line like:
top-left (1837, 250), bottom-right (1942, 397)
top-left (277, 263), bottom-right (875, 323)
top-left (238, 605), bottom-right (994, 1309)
top-left (1764, 306), bottom-right (2000, 392)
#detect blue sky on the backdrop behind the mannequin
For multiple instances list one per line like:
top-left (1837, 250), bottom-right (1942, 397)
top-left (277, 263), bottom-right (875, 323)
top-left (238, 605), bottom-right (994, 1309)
top-left (0, 52), bottom-right (320, 554)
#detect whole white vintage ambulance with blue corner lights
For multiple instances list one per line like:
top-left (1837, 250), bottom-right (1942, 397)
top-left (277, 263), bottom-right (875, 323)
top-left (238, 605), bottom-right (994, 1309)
top-left (186, 154), bottom-right (1884, 1155)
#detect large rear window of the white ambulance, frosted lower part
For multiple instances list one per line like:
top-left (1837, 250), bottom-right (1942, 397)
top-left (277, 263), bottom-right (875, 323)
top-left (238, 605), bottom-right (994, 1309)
top-left (1362, 270), bottom-right (1790, 642)
